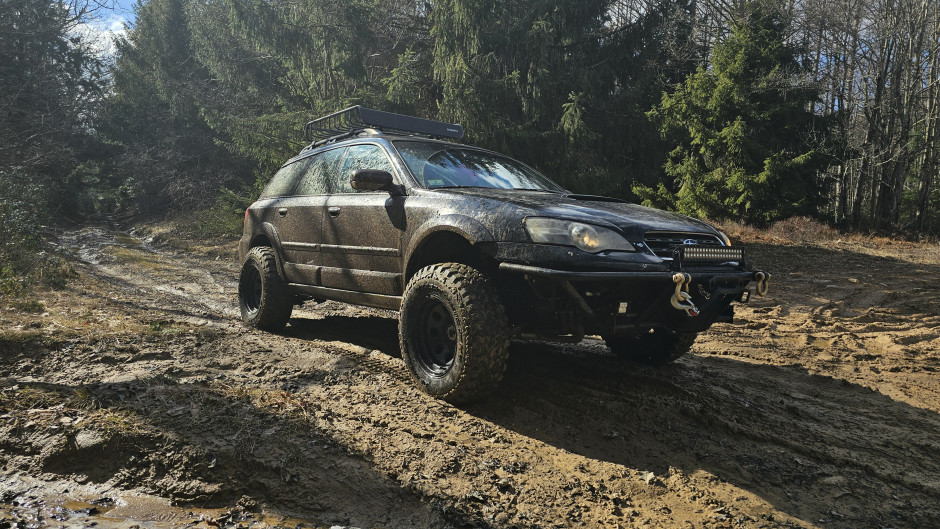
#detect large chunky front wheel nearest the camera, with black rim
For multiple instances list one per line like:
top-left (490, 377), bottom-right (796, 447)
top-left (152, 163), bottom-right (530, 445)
top-left (398, 263), bottom-right (509, 403)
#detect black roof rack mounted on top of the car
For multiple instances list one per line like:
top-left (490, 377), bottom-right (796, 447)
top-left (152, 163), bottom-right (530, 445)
top-left (304, 105), bottom-right (463, 145)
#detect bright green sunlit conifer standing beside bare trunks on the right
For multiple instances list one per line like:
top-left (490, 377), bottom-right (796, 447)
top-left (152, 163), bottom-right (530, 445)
top-left (635, 3), bottom-right (826, 224)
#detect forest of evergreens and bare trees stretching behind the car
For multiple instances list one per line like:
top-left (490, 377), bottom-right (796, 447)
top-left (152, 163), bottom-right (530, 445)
top-left (0, 0), bottom-right (940, 288)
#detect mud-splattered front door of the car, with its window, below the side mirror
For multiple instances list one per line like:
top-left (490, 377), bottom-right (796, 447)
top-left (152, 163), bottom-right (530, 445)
top-left (321, 143), bottom-right (405, 295)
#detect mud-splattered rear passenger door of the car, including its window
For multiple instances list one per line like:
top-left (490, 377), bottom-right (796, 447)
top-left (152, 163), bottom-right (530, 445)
top-left (276, 148), bottom-right (344, 285)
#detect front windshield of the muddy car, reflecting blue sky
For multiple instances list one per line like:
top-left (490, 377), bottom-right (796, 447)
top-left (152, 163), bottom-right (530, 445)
top-left (394, 141), bottom-right (564, 192)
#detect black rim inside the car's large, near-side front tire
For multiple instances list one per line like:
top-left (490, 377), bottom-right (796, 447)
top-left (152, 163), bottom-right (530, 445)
top-left (412, 295), bottom-right (457, 378)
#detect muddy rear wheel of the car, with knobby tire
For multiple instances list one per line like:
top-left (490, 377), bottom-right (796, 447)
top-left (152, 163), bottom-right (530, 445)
top-left (238, 246), bottom-right (294, 332)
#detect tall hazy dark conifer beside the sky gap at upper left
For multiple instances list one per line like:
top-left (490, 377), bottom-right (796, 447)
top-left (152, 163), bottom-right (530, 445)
top-left (102, 0), bottom-right (244, 212)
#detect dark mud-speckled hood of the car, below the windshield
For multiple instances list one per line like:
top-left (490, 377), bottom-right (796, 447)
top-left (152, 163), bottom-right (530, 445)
top-left (435, 188), bottom-right (718, 237)
